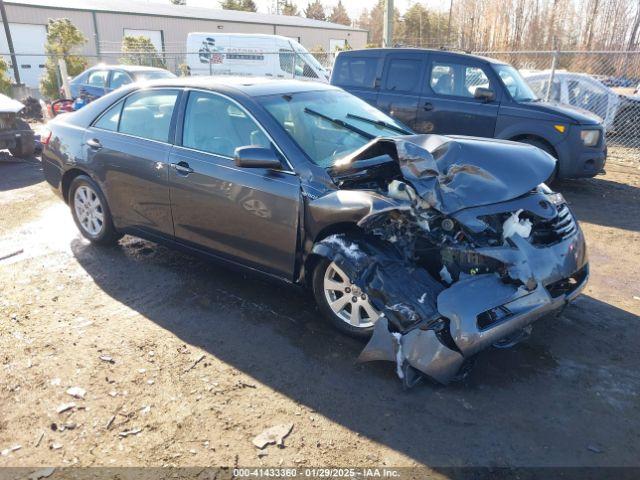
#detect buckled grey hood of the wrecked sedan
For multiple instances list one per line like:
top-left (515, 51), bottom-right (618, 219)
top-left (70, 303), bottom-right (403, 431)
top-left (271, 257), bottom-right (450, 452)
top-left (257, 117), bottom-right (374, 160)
top-left (340, 135), bottom-right (555, 214)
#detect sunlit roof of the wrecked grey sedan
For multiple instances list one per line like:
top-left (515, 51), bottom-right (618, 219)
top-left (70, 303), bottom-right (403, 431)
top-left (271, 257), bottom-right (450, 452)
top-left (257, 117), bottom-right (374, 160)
top-left (138, 75), bottom-right (340, 97)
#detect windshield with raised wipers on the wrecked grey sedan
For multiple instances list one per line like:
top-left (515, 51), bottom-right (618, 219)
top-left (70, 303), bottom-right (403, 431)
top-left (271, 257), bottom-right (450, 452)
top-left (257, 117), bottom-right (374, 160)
top-left (258, 90), bottom-right (413, 168)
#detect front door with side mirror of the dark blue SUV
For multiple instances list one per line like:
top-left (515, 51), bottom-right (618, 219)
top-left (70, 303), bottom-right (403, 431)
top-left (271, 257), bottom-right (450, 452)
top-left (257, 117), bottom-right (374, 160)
top-left (415, 53), bottom-right (500, 137)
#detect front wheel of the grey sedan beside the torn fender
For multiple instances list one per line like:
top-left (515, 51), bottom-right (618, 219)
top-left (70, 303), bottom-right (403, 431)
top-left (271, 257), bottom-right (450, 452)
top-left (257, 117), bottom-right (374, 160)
top-left (313, 259), bottom-right (380, 338)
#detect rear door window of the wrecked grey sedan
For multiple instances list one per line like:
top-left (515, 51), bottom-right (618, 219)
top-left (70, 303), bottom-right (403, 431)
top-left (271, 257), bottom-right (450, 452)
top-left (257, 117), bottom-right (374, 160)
top-left (118, 90), bottom-right (178, 142)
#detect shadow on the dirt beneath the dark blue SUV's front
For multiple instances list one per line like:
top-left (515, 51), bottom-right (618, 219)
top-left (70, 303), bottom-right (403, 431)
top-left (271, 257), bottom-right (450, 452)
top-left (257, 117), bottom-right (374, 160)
top-left (553, 177), bottom-right (640, 232)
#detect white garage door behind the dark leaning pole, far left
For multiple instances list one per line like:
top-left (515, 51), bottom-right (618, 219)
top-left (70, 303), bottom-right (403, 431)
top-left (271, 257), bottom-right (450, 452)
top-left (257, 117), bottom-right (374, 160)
top-left (0, 23), bottom-right (47, 88)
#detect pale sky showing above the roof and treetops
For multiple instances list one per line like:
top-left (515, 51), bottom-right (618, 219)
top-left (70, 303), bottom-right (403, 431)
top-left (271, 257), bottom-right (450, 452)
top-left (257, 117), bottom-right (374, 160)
top-left (142, 0), bottom-right (449, 19)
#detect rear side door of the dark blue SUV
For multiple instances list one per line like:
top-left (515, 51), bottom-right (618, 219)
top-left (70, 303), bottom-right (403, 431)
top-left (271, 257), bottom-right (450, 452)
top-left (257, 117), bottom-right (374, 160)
top-left (377, 52), bottom-right (428, 128)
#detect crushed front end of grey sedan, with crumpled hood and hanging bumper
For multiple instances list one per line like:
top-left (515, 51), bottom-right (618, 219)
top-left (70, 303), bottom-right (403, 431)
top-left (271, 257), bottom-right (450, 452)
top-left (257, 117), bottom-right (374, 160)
top-left (309, 135), bottom-right (588, 387)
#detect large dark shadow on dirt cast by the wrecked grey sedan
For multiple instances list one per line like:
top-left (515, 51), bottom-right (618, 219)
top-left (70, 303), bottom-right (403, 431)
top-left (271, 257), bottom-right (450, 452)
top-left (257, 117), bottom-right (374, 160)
top-left (72, 237), bottom-right (640, 468)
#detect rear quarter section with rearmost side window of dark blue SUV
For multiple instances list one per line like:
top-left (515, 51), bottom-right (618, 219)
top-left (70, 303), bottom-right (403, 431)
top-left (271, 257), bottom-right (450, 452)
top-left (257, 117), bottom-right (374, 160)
top-left (331, 53), bottom-right (383, 106)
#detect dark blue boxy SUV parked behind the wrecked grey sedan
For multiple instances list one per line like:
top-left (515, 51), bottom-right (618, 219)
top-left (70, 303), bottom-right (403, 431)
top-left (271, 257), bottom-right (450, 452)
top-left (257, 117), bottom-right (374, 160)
top-left (331, 48), bottom-right (606, 178)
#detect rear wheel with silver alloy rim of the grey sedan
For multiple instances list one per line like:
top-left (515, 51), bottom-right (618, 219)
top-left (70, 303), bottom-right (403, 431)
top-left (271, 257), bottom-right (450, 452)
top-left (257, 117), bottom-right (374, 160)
top-left (69, 175), bottom-right (122, 245)
